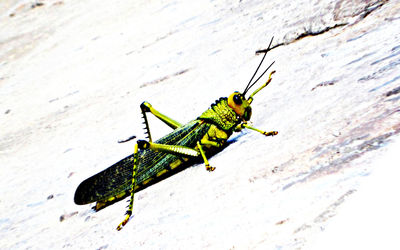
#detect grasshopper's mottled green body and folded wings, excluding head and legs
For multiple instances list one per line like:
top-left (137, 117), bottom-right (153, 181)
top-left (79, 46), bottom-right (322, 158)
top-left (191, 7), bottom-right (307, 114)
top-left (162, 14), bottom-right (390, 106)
top-left (75, 98), bottom-right (240, 209)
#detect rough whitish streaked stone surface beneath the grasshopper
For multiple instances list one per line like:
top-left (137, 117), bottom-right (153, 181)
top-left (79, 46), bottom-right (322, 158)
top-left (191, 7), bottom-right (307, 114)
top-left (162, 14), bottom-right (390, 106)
top-left (0, 0), bottom-right (400, 249)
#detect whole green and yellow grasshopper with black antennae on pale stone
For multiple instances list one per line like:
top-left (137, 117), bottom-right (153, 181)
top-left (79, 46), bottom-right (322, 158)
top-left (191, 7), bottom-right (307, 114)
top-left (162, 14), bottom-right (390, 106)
top-left (74, 38), bottom-right (278, 230)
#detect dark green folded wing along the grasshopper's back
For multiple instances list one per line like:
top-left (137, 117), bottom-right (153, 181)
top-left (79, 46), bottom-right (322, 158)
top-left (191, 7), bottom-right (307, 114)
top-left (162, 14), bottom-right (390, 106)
top-left (74, 120), bottom-right (209, 205)
